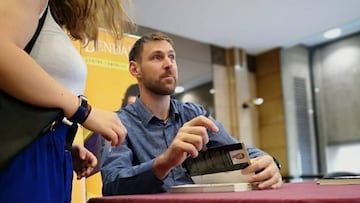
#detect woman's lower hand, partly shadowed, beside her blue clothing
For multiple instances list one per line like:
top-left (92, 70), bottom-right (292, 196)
top-left (71, 145), bottom-right (97, 180)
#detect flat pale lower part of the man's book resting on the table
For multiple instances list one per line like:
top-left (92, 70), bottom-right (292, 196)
top-left (170, 183), bottom-right (257, 193)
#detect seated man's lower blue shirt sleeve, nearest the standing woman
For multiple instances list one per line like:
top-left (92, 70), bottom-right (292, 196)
top-left (101, 141), bottom-right (165, 196)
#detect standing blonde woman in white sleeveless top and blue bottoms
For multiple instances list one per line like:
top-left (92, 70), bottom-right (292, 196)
top-left (0, 0), bottom-right (133, 203)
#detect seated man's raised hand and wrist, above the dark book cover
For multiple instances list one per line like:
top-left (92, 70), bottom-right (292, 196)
top-left (153, 116), bottom-right (219, 179)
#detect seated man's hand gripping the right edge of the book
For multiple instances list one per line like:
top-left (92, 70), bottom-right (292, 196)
top-left (242, 155), bottom-right (282, 189)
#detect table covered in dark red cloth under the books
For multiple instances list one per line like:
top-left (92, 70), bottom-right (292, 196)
top-left (88, 181), bottom-right (360, 203)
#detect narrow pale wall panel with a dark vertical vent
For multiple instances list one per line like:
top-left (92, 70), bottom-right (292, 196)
top-left (281, 46), bottom-right (318, 177)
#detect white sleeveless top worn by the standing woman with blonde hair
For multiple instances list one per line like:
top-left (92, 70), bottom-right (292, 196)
top-left (30, 4), bottom-right (87, 95)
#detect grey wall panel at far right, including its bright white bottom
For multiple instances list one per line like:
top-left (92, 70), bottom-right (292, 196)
top-left (312, 33), bottom-right (360, 172)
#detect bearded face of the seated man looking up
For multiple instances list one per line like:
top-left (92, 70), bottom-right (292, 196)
top-left (139, 40), bottom-right (178, 95)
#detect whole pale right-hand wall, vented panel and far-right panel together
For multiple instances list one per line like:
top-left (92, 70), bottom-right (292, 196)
top-left (281, 34), bottom-right (360, 177)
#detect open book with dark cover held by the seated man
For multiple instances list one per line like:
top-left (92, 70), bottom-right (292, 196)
top-left (170, 143), bottom-right (257, 192)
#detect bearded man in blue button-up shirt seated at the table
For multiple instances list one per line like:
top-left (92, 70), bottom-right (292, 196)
top-left (101, 33), bottom-right (282, 196)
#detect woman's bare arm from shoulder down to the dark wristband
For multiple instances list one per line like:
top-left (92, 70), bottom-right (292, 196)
top-left (0, 0), bottom-right (79, 117)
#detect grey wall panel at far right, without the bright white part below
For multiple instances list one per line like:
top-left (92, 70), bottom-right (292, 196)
top-left (313, 35), bottom-right (360, 144)
